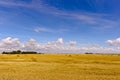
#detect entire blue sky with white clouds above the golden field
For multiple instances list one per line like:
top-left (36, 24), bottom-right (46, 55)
top-left (0, 0), bottom-right (120, 53)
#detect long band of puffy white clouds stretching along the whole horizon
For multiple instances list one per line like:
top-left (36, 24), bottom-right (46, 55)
top-left (0, 37), bottom-right (120, 53)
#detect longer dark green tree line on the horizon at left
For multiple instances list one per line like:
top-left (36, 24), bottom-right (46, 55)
top-left (2, 50), bottom-right (42, 54)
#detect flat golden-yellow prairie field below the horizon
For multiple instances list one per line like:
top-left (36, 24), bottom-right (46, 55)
top-left (0, 54), bottom-right (120, 80)
